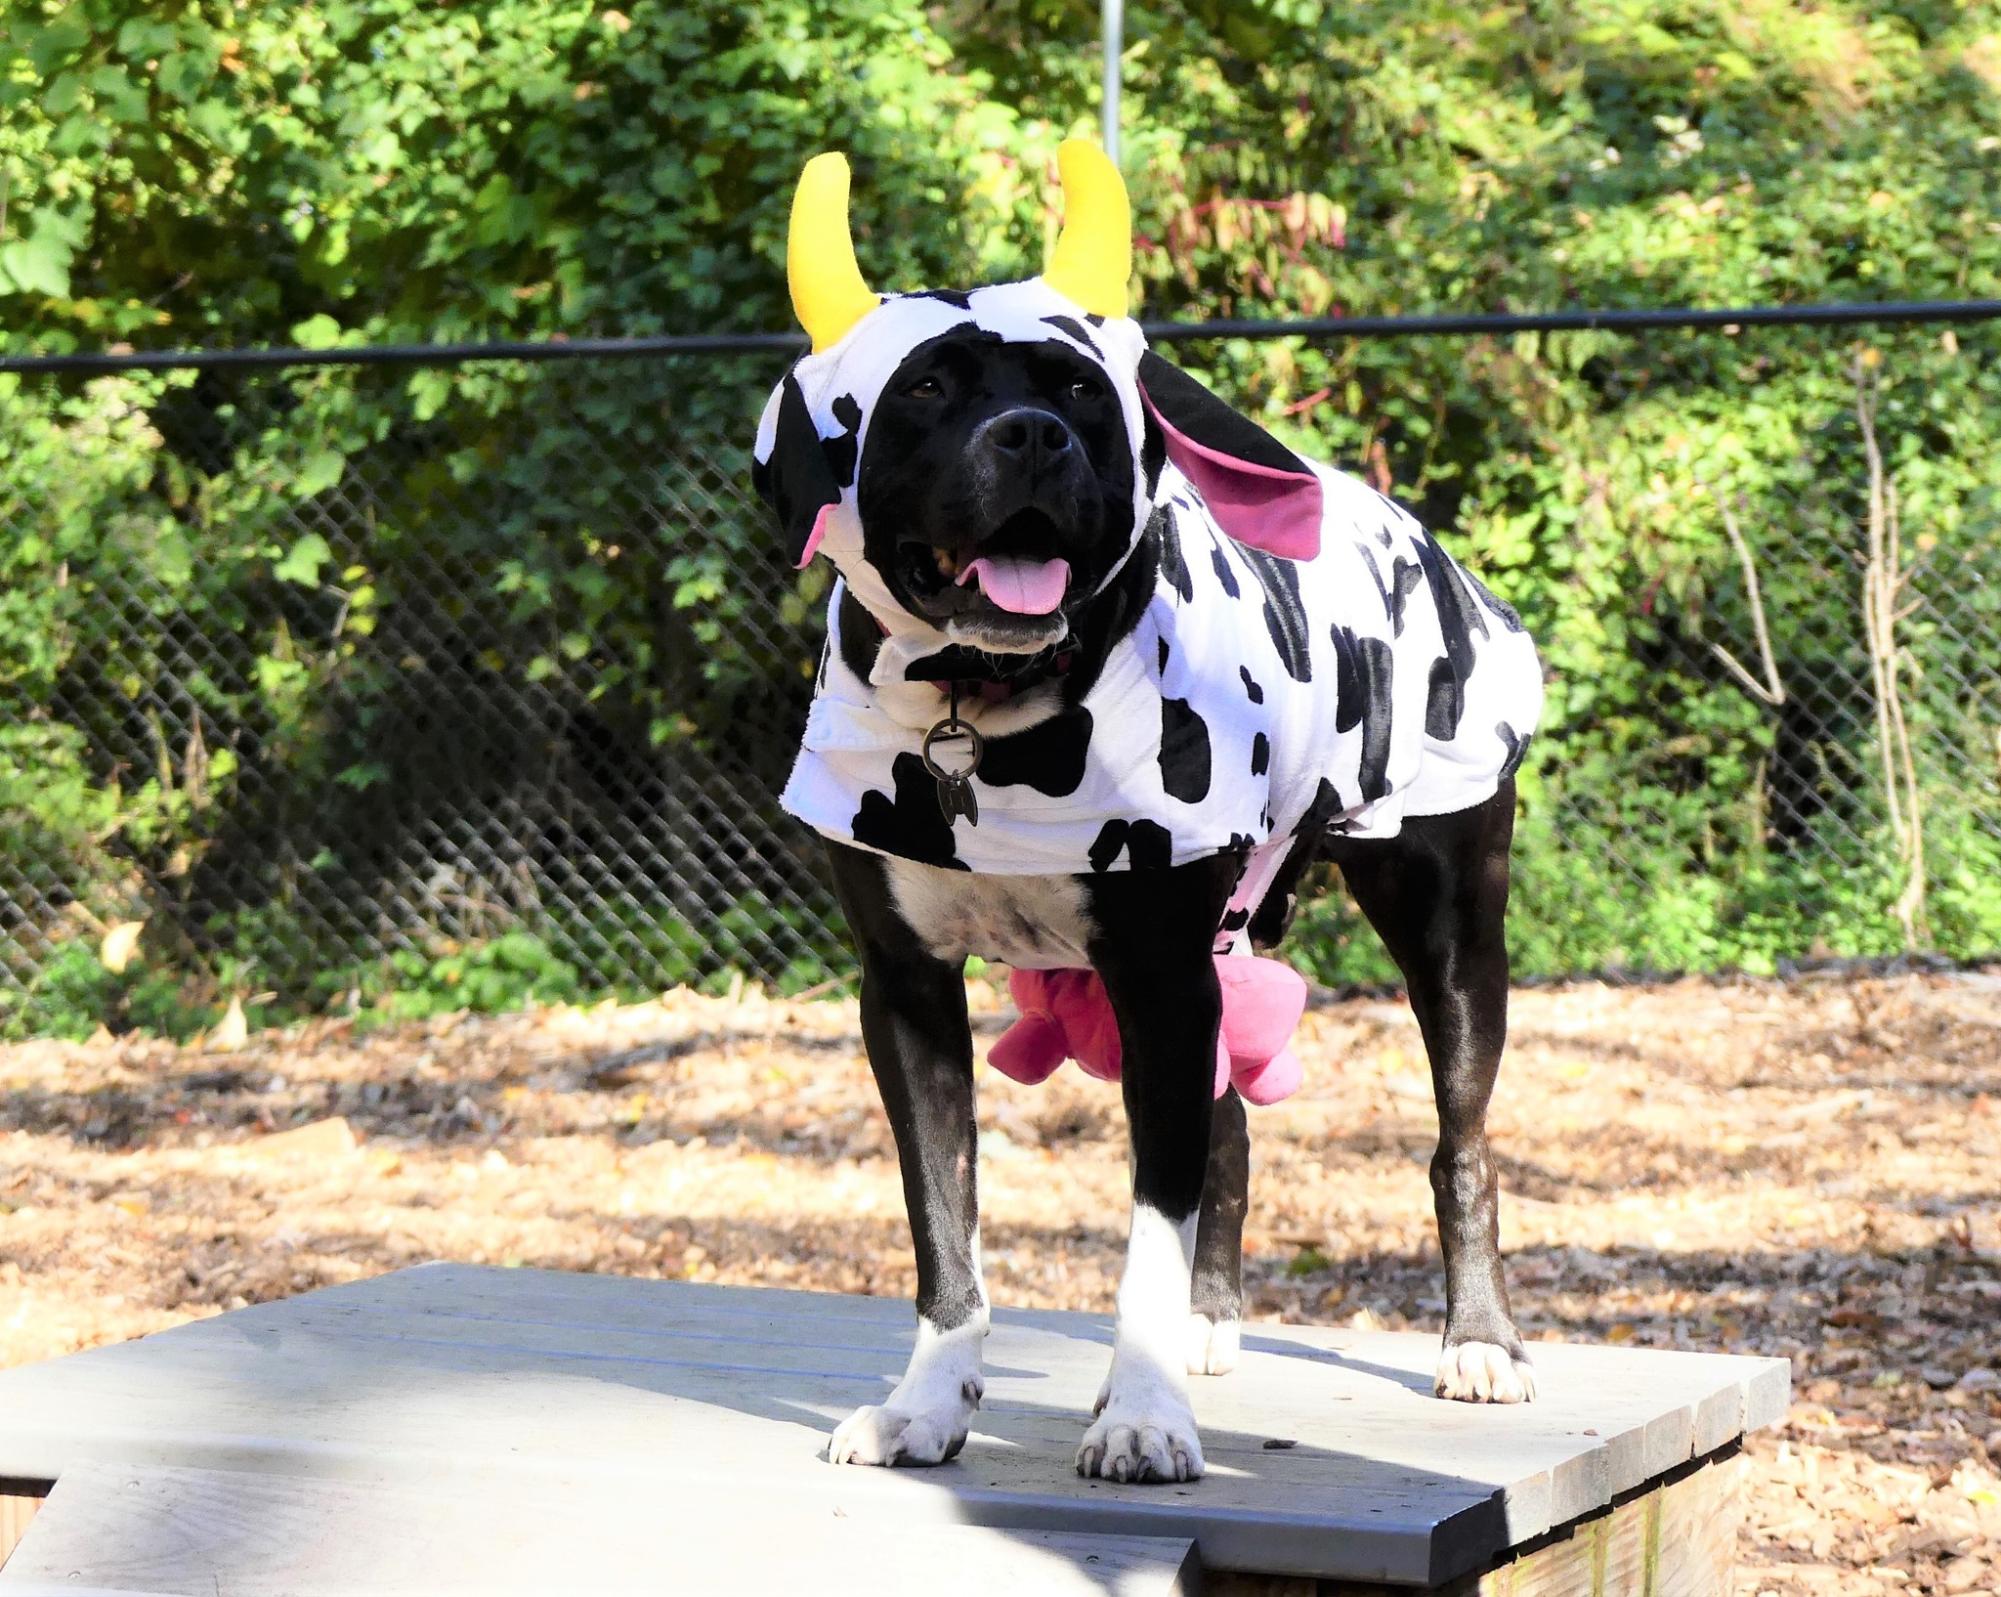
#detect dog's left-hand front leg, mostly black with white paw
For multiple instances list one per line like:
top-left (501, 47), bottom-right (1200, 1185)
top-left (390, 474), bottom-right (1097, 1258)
top-left (826, 847), bottom-right (986, 1465)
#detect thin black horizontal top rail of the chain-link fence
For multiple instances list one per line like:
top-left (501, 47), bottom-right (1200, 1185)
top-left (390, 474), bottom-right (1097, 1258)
top-left (0, 300), bottom-right (2001, 372)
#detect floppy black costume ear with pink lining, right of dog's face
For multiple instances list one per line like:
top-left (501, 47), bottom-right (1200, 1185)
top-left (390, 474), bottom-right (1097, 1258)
top-left (1139, 350), bottom-right (1325, 560)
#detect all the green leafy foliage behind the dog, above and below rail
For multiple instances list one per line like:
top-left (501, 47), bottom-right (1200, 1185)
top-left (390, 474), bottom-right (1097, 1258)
top-left (0, 0), bottom-right (2001, 1033)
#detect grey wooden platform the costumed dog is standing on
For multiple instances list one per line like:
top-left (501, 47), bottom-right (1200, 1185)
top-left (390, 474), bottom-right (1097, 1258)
top-left (0, 1265), bottom-right (1789, 1597)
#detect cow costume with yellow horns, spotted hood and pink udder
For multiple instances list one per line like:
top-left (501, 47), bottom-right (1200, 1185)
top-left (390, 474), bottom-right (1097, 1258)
top-left (754, 142), bottom-right (1543, 1103)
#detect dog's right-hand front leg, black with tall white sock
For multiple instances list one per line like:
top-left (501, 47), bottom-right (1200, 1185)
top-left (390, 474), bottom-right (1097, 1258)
top-left (1077, 867), bottom-right (1229, 1481)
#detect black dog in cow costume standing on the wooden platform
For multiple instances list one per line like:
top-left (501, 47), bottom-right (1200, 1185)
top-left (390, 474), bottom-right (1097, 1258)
top-left (756, 142), bottom-right (1541, 1481)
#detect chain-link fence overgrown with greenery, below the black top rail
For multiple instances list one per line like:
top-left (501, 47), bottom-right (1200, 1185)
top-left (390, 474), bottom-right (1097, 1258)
top-left (0, 324), bottom-right (2001, 1033)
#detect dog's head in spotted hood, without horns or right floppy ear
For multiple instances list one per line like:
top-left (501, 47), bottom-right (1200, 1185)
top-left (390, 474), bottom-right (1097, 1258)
top-left (756, 268), bottom-right (1165, 652)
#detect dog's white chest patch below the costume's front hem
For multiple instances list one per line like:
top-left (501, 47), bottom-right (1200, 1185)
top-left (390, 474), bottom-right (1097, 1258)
top-left (882, 859), bottom-right (1091, 971)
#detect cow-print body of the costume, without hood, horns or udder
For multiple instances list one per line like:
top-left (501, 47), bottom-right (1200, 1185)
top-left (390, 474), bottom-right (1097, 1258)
top-left (782, 468), bottom-right (1543, 943)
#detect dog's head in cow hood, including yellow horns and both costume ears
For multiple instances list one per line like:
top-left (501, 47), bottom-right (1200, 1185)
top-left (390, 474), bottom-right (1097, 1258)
top-left (756, 142), bottom-right (1321, 676)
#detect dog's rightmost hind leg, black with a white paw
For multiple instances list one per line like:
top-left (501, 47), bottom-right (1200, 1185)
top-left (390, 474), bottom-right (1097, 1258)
top-left (1327, 778), bottom-right (1535, 1403)
